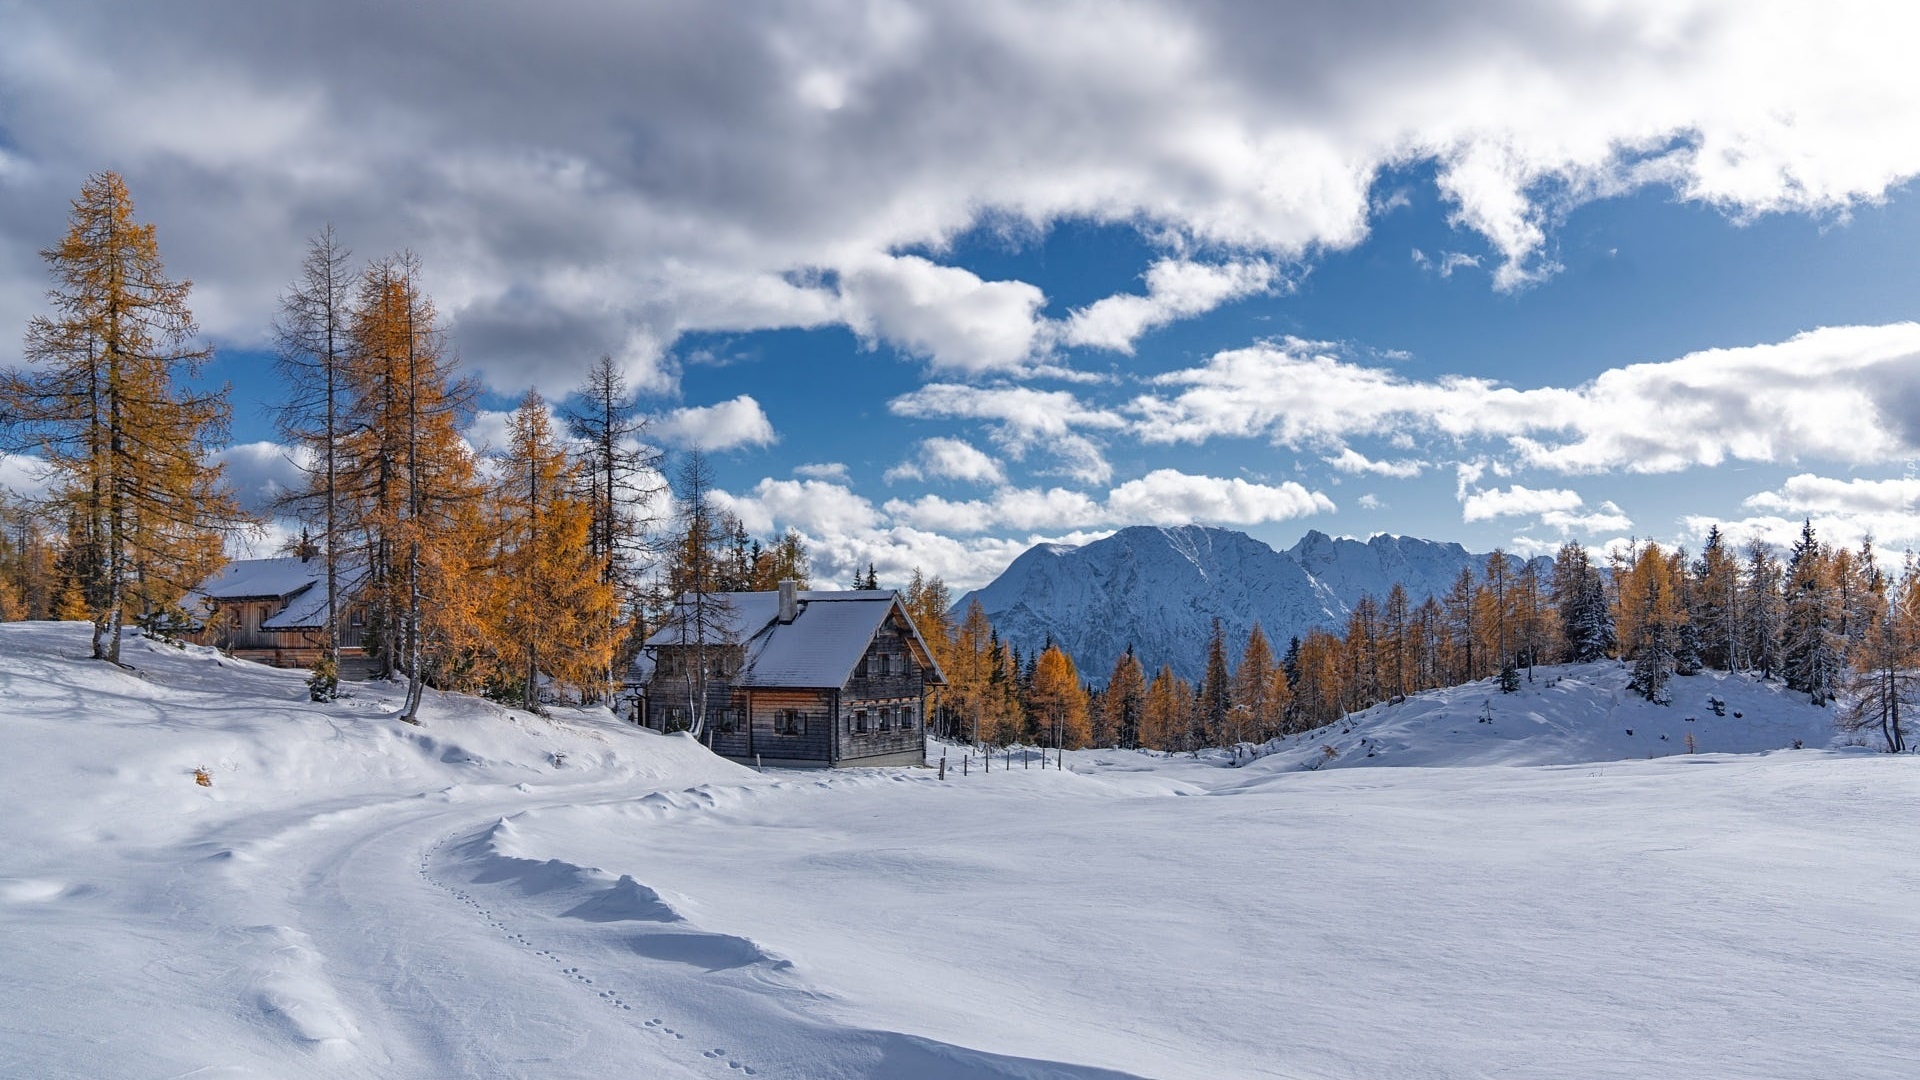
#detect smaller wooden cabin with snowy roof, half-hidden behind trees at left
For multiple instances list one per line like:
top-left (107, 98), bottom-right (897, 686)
top-left (186, 557), bottom-right (365, 667)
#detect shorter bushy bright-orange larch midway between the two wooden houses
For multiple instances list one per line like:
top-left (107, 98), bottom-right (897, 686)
top-left (493, 390), bottom-right (616, 713)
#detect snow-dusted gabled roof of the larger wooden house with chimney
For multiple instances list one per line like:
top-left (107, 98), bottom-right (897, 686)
top-left (636, 588), bottom-right (947, 688)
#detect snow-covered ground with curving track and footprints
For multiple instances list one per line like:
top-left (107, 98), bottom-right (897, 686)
top-left (0, 625), bottom-right (1920, 1080)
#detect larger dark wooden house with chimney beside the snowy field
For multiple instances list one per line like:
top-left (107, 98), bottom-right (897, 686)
top-left (628, 582), bottom-right (945, 767)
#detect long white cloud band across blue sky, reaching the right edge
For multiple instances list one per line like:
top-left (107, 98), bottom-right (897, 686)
top-left (1129, 323), bottom-right (1920, 473)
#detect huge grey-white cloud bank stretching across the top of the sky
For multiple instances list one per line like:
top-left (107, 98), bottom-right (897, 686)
top-left (0, 0), bottom-right (1920, 392)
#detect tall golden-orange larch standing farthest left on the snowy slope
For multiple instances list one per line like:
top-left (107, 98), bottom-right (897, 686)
top-left (0, 173), bottom-right (246, 663)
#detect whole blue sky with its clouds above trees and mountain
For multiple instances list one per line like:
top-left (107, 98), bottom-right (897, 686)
top-left (0, 0), bottom-right (1920, 586)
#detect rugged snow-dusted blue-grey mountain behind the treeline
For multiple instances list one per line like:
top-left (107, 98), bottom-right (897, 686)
top-left (954, 525), bottom-right (1551, 684)
